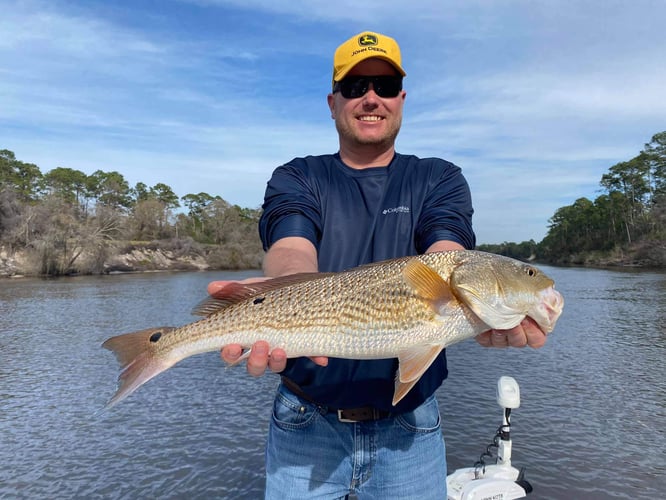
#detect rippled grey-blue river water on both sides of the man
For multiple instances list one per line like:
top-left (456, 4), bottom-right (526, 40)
top-left (0, 268), bottom-right (666, 499)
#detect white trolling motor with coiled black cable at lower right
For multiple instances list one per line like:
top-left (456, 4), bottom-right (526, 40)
top-left (446, 377), bottom-right (532, 500)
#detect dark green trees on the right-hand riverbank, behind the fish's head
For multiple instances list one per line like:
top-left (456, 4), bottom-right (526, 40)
top-left (479, 131), bottom-right (666, 267)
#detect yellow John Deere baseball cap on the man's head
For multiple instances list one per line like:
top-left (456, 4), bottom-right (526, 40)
top-left (333, 31), bottom-right (407, 88)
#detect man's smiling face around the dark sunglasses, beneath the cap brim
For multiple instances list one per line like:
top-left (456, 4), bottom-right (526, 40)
top-left (328, 58), bottom-right (407, 148)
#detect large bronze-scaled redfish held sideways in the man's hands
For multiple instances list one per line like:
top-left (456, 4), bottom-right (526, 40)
top-left (102, 250), bottom-right (564, 409)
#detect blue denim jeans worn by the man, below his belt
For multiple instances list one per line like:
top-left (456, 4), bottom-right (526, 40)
top-left (266, 385), bottom-right (446, 500)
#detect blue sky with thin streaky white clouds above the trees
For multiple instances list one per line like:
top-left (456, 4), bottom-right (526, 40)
top-left (0, 0), bottom-right (666, 243)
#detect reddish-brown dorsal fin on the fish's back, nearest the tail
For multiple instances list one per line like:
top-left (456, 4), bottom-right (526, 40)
top-left (192, 273), bottom-right (332, 316)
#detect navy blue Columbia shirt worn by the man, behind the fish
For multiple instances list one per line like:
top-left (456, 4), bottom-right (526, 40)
top-left (259, 154), bottom-right (475, 412)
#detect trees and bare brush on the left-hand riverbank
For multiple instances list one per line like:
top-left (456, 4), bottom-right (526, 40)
top-left (0, 150), bottom-right (263, 275)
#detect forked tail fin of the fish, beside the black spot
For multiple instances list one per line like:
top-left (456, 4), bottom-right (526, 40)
top-left (102, 327), bottom-right (177, 410)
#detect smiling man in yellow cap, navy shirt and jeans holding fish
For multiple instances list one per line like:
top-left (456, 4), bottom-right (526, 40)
top-left (209, 32), bottom-right (545, 499)
